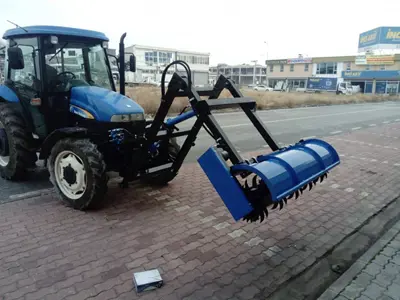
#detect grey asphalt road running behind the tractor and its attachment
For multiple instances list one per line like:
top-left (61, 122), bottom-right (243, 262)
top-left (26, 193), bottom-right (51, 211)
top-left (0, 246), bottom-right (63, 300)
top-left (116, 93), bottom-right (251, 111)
top-left (0, 102), bottom-right (400, 203)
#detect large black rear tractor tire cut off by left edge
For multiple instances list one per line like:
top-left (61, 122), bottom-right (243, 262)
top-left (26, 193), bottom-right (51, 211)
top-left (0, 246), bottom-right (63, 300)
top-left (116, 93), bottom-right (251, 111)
top-left (0, 103), bottom-right (37, 181)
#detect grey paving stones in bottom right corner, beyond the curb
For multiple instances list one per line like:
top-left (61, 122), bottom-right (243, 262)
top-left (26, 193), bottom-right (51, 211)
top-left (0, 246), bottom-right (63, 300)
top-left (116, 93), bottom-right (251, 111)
top-left (319, 222), bottom-right (400, 300)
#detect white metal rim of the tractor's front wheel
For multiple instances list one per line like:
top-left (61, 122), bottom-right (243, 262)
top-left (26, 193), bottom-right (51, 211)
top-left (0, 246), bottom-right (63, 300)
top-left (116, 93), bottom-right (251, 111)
top-left (54, 151), bottom-right (87, 200)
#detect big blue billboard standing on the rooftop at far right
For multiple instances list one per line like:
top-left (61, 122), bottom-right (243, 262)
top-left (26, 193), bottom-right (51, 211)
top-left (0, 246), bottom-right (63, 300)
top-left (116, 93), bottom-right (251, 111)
top-left (358, 27), bottom-right (400, 52)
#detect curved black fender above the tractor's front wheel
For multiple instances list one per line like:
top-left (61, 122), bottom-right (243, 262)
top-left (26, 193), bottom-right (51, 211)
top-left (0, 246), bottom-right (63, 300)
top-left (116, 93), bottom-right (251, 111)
top-left (39, 127), bottom-right (88, 159)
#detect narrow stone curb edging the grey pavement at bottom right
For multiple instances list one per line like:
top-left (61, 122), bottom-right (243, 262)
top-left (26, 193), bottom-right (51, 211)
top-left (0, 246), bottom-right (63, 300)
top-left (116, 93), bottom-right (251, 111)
top-left (317, 221), bottom-right (400, 300)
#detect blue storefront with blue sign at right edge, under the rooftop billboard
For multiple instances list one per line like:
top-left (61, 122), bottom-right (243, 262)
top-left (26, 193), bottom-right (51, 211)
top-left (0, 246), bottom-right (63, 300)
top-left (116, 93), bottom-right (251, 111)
top-left (342, 70), bottom-right (400, 94)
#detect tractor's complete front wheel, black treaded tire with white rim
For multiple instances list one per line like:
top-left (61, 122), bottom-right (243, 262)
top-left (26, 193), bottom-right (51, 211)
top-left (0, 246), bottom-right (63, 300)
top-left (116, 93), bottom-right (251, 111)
top-left (48, 138), bottom-right (108, 210)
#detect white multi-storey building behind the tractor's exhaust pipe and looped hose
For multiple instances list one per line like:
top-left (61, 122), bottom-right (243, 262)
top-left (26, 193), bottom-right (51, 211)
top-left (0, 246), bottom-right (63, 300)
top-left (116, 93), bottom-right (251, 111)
top-left (125, 45), bottom-right (210, 86)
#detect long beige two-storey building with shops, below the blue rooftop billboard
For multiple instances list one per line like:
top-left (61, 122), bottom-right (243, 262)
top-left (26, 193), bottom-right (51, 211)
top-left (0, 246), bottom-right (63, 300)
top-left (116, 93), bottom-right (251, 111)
top-left (266, 54), bottom-right (400, 94)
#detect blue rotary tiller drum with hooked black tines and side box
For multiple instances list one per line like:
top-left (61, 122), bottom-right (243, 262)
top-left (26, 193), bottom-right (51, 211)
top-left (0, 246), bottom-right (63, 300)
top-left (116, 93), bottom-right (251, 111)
top-left (198, 139), bottom-right (340, 222)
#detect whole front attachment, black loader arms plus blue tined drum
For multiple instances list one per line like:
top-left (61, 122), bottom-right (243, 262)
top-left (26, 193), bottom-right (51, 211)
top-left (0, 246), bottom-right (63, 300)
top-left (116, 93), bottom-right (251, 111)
top-left (146, 62), bottom-right (340, 222)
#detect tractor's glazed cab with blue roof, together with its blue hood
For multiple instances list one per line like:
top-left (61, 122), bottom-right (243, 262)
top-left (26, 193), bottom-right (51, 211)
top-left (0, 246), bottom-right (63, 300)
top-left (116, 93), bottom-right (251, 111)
top-left (3, 26), bottom-right (139, 139)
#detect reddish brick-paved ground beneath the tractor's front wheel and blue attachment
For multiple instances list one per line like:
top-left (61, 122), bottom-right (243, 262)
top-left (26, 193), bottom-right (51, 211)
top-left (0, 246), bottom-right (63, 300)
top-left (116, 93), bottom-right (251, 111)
top-left (0, 123), bottom-right (400, 300)
